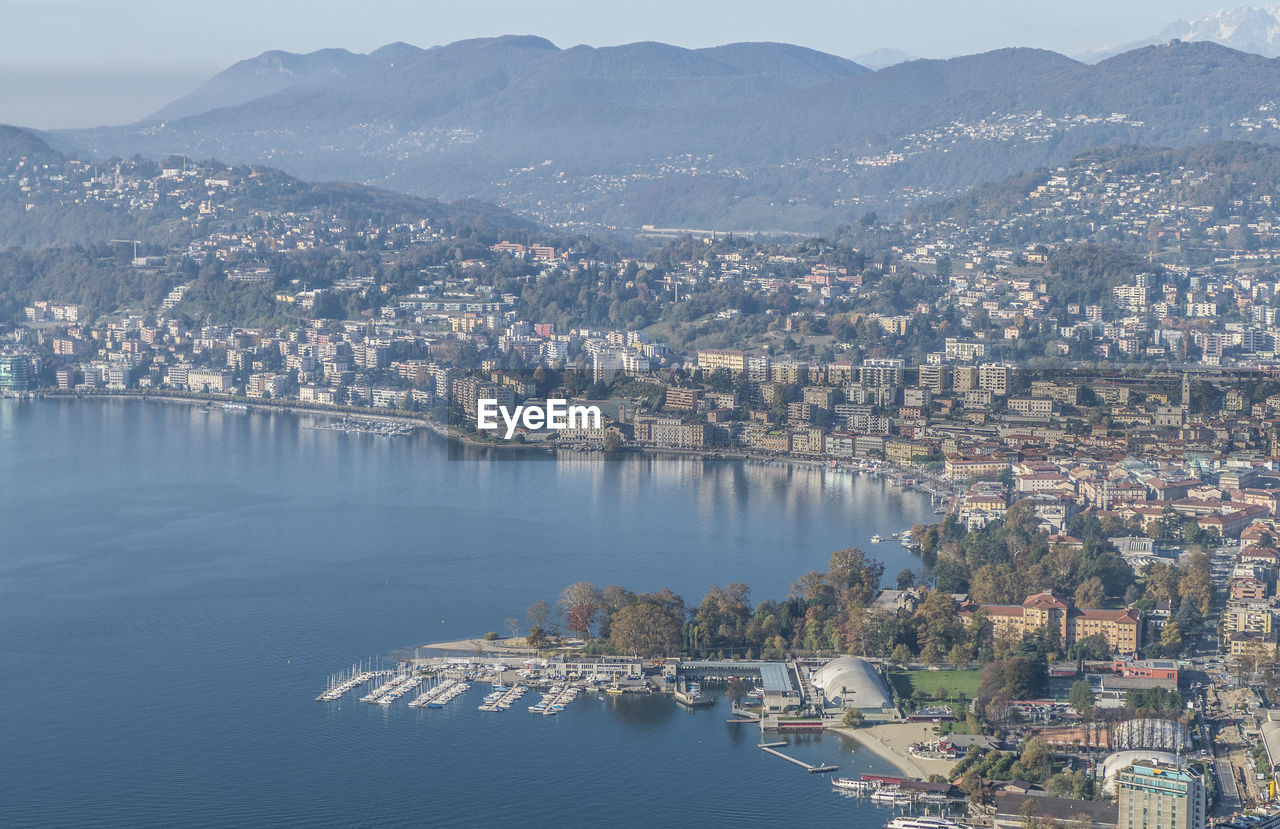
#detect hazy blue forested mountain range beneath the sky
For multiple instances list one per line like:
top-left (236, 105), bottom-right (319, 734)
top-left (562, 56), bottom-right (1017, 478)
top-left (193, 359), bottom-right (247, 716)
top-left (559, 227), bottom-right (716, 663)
top-left (30, 36), bottom-right (1280, 230)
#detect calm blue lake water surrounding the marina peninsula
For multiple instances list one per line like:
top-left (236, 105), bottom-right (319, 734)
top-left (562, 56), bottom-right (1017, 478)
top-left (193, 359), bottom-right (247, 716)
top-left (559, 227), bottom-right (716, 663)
top-left (0, 400), bottom-right (932, 826)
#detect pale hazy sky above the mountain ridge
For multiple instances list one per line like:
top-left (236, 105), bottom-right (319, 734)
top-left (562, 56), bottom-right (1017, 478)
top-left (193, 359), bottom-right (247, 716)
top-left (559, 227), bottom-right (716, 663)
top-left (0, 0), bottom-right (1254, 129)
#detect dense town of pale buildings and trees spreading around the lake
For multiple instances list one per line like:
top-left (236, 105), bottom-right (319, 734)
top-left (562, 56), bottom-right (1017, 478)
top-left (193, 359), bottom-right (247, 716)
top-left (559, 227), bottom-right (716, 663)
top-left (10, 139), bottom-right (1280, 829)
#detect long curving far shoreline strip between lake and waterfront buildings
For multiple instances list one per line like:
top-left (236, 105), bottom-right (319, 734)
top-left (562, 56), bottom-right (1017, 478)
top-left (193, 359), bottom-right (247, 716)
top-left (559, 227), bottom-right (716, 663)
top-left (15, 389), bottom-right (957, 500)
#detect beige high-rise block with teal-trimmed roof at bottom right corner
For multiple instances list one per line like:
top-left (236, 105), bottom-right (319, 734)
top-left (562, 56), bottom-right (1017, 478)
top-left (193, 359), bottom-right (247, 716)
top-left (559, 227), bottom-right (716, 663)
top-left (1116, 760), bottom-right (1206, 829)
